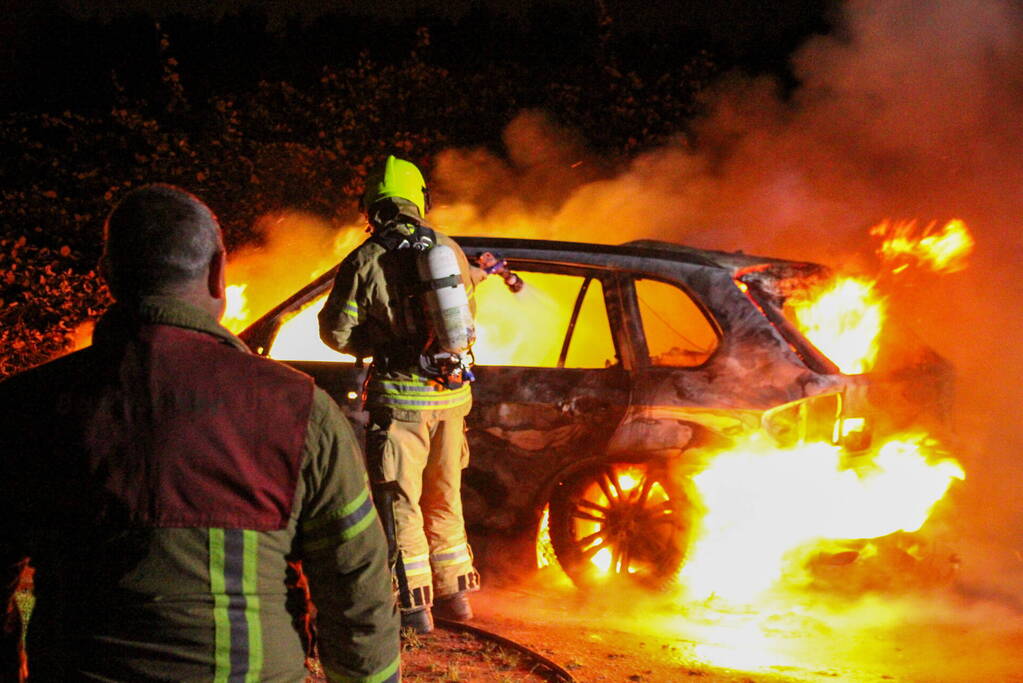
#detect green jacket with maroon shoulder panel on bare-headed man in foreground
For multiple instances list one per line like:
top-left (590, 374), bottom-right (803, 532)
top-left (0, 298), bottom-right (401, 682)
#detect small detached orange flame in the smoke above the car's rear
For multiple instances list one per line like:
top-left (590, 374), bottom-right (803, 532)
top-left (871, 219), bottom-right (975, 273)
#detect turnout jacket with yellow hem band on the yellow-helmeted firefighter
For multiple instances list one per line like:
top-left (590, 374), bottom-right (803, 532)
top-left (319, 223), bottom-right (486, 421)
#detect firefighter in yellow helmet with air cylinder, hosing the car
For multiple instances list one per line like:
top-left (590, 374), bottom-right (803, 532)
top-left (319, 156), bottom-right (486, 633)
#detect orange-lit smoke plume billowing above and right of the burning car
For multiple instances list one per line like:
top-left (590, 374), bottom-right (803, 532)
top-left (433, 0), bottom-right (1023, 604)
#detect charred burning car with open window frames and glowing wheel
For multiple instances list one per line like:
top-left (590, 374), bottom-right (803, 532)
top-left (240, 237), bottom-right (949, 587)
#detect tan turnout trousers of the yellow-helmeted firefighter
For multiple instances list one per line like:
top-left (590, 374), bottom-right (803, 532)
top-left (366, 409), bottom-right (479, 610)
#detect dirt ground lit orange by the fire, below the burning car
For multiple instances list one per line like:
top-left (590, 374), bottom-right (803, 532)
top-left (405, 575), bottom-right (1023, 683)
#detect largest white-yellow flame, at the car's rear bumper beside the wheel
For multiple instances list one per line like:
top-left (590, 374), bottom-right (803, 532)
top-left (680, 436), bottom-right (965, 603)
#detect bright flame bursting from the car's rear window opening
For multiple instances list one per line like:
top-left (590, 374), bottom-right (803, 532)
top-left (786, 277), bottom-right (887, 374)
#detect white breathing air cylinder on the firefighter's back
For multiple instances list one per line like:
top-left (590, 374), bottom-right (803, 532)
top-left (416, 244), bottom-right (476, 356)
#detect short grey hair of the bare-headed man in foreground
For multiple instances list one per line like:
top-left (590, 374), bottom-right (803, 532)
top-left (103, 184), bottom-right (224, 299)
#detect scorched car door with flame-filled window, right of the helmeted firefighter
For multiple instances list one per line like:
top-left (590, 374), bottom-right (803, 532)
top-left (463, 260), bottom-right (630, 532)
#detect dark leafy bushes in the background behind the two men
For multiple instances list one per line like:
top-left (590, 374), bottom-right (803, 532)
top-left (0, 21), bottom-right (713, 377)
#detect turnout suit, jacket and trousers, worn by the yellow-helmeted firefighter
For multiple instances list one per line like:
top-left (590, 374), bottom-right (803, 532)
top-left (319, 215), bottom-right (485, 609)
